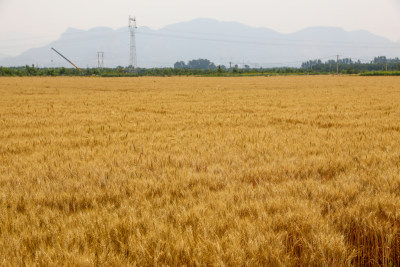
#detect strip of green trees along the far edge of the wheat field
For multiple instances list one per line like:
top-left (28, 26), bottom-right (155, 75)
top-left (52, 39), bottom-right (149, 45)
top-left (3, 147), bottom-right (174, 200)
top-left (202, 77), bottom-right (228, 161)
top-left (0, 56), bottom-right (400, 77)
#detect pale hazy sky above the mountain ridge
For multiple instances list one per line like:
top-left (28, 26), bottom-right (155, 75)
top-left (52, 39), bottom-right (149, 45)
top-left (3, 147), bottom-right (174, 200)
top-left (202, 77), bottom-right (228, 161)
top-left (0, 0), bottom-right (400, 57)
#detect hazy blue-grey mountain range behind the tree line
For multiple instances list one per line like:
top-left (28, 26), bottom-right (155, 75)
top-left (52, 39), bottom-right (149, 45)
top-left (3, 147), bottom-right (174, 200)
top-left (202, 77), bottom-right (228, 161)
top-left (0, 19), bottom-right (400, 68)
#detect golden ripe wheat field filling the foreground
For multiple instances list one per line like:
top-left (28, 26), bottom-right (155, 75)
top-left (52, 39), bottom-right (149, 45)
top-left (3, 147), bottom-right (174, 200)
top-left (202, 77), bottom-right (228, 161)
top-left (0, 76), bottom-right (400, 266)
